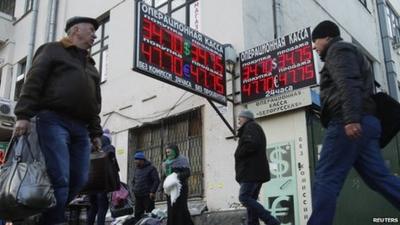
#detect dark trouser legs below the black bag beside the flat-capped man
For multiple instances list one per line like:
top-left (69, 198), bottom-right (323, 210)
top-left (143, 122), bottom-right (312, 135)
top-left (87, 193), bottom-right (108, 225)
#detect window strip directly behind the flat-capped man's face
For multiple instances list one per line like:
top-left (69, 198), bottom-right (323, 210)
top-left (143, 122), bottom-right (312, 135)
top-left (90, 13), bottom-right (110, 83)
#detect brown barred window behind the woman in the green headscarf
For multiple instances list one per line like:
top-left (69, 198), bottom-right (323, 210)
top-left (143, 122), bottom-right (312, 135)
top-left (128, 108), bottom-right (204, 200)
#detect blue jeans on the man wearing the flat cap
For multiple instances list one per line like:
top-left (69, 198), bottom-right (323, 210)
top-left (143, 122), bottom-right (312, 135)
top-left (37, 111), bottom-right (90, 225)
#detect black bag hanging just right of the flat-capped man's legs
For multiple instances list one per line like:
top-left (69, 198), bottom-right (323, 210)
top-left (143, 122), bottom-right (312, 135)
top-left (81, 151), bottom-right (120, 194)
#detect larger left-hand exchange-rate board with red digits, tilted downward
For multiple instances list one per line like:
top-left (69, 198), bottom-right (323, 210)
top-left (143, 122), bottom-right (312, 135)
top-left (133, 1), bottom-right (226, 105)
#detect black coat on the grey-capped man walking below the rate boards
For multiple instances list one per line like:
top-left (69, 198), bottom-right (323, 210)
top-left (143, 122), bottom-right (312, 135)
top-left (235, 120), bottom-right (270, 183)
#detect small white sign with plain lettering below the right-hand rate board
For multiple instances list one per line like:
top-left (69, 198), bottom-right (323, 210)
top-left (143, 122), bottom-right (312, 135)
top-left (247, 88), bottom-right (312, 118)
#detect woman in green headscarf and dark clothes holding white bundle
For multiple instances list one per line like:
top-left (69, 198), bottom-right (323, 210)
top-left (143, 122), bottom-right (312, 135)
top-left (162, 144), bottom-right (193, 225)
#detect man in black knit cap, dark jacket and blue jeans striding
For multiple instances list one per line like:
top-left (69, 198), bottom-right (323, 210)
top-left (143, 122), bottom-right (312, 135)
top-left (308, 21), bottom-right (400, 225)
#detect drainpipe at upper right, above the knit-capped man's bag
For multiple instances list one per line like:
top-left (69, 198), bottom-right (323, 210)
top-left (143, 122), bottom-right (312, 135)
top-left (376, 0), bottom-right (398, 99)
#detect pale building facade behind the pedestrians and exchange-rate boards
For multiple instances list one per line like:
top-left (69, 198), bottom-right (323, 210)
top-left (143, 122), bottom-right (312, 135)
top-left (0, 0), bottom-right (400, 225)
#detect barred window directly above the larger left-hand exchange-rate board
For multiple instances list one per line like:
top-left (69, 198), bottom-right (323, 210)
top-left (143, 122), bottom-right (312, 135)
top-left (144, 0), bottom-right (199, 30)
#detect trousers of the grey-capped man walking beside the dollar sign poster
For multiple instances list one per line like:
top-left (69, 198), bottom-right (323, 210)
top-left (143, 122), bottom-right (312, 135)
top-left (239, 182), bottom-right (280, 225)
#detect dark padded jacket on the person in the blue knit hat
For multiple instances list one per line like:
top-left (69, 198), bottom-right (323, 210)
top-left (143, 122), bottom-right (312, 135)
top-left (133, 160), bottom-right (160, 196)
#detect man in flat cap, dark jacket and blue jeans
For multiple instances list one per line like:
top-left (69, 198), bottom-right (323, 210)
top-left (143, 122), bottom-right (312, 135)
top-left (14, 17), bottom-right (102, 225)
